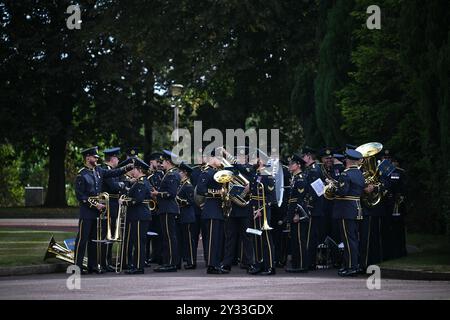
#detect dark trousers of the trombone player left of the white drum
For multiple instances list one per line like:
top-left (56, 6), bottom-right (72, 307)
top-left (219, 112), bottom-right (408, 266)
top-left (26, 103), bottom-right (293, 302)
top-left (253, 217), bottom-right (275, 270)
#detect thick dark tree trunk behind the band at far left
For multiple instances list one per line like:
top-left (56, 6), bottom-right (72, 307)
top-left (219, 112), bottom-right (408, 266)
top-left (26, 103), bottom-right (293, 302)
top-left (45, 134), bottom-right (67, 207)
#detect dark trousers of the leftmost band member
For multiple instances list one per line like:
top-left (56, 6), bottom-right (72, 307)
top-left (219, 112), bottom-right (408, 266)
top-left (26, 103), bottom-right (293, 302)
top-left (75, 219), bottom-right (100, 269)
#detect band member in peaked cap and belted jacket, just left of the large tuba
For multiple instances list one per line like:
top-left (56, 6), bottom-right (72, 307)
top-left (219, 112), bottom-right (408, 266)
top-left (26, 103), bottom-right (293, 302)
top-left (333, 150), bottom-right (365, 277)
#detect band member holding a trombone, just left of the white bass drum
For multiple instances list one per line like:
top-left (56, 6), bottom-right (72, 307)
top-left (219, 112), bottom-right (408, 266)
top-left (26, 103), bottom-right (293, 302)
top-left (248, 157), bottom-right (276, 275)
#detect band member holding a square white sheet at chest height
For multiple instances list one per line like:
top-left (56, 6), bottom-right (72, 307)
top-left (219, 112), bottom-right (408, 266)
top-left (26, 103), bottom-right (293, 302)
top-left (302, 147), bottom-right (325, 270)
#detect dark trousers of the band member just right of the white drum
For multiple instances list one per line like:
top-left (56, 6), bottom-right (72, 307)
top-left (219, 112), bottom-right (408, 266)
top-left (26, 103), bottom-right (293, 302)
top-left (290, 221), bottom-right (309, 269)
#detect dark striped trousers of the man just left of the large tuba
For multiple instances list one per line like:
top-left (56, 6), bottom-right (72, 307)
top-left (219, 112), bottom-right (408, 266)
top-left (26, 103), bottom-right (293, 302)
top-left (339, 219), bottom-right (359, 269)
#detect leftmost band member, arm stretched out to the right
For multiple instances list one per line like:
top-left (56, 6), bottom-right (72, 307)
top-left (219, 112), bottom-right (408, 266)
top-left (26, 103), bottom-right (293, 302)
top-left (75, 147), bottom-right (133, 273)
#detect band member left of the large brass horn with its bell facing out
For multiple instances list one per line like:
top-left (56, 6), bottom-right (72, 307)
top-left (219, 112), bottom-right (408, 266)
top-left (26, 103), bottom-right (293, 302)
top-left (197, 150), bottom-right (228, 274)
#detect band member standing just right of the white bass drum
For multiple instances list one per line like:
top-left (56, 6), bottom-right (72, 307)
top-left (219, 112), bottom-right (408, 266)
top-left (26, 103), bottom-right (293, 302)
top-left (286, 155), bottom-right (310, 272)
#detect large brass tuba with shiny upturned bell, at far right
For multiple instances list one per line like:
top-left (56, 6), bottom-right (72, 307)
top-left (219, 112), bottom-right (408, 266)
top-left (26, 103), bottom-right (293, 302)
top-left (355, 142), bottom-right (383, 208)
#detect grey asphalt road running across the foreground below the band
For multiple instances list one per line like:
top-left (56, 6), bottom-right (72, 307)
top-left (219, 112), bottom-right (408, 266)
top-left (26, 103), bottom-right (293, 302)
top-left (0, 267), bottom-right (450, 300)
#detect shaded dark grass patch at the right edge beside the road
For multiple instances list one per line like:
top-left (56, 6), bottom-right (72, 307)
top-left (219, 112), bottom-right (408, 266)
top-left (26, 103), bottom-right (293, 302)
top-left (380, 234), bottom-right (450, 272)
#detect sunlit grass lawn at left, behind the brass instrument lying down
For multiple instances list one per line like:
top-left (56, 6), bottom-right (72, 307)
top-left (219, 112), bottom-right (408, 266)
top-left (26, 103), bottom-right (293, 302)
top-left (0, 228), bottom-right (76, 267)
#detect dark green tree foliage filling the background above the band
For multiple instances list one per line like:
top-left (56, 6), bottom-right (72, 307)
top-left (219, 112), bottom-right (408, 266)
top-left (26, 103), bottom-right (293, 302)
top-left (0, 0), bottom-right (450, 236)
